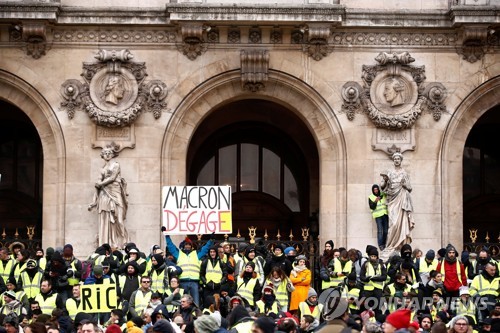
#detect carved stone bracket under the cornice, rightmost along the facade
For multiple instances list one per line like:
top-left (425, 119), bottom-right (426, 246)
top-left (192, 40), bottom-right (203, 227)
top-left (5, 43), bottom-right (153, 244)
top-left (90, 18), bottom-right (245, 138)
top-left (457, 25), bottom-right (488, 63)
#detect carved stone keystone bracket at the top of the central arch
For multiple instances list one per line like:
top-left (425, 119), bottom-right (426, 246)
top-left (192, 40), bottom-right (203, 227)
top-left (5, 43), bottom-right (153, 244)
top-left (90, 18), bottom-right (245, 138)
top-left (240, 50), bottom-right (269, 92)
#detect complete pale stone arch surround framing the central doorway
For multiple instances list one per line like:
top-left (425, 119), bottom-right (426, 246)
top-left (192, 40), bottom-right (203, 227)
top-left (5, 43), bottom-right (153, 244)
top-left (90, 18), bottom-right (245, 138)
top-left (161, 70), bottom-right (347, 244)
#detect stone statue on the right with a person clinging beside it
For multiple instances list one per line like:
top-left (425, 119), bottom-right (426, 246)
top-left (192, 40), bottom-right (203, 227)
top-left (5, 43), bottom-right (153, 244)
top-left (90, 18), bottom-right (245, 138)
top-left (380, 153), bottom-right (415, 250)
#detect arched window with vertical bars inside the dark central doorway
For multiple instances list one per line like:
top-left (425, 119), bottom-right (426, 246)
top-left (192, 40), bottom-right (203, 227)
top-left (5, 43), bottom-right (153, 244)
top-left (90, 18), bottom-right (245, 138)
top-left (196, 142), bottom-right (301, 212)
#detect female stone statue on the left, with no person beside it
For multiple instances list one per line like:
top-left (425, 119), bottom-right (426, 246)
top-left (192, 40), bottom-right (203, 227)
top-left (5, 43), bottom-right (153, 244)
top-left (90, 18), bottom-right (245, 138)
top-left (88, 143), bottom-right (128, 248)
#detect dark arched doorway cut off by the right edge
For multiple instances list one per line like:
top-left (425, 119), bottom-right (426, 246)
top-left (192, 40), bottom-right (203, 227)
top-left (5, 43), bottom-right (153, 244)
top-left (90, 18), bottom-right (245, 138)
top-left (463, 105), bottom-right (500, 243)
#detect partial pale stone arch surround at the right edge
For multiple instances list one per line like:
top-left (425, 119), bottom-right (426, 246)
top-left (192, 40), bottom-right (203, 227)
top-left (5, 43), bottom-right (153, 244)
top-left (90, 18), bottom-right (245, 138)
top-left (440, 76), bottom-right (500, 248)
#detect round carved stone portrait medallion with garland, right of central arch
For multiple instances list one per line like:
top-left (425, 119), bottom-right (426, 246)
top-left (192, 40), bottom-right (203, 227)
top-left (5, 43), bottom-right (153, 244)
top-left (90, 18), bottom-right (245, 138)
top-left (342, 52), bottom-right (446, 130)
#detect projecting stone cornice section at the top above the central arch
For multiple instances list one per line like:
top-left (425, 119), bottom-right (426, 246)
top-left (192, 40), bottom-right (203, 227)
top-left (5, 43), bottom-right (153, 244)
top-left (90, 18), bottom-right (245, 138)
top-left (166, 4), bottom-right (344, 23)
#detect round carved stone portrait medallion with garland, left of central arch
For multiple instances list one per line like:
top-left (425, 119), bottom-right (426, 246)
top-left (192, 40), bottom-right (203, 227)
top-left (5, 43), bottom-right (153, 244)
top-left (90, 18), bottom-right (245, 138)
top-left (61, 50), bottom-right (167, 127)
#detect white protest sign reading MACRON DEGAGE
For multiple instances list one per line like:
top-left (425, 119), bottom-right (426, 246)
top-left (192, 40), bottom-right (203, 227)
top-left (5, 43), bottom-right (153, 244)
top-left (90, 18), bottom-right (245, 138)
top-left (161, 186), bottom-right (233, 235)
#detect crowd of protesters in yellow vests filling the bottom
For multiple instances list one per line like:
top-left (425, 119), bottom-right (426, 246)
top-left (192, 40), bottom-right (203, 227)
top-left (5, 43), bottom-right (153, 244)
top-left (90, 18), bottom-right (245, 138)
top-left (0, 230), bottom-right (500, 333)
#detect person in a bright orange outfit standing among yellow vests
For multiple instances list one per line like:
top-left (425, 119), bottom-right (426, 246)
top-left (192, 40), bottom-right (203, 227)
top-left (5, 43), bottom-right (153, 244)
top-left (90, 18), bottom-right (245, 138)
top-left (289, 255), bottom-right (312, 313)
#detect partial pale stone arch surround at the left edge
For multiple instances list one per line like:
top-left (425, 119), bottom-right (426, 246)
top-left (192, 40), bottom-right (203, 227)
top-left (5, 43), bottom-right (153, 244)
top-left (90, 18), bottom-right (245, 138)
top-left (0, 70), bottom-right (66, 247)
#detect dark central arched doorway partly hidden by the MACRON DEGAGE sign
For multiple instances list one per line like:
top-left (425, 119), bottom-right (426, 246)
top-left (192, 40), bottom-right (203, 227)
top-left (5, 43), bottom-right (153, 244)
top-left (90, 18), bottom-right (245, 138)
top-left (186, 99), bottom-right (319, 238)
